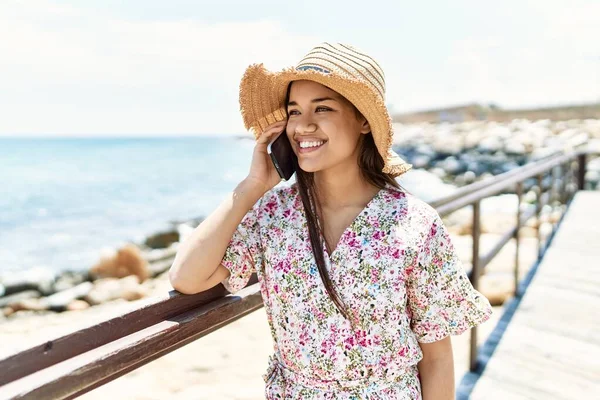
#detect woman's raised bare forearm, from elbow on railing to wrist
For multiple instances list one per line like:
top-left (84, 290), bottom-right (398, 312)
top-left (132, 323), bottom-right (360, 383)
top-left (169, 181), bottom-right (264, 293)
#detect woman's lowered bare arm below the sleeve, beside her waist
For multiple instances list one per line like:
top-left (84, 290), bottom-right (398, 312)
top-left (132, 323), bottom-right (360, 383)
top-left (418, 339), bottom-right (455, 400)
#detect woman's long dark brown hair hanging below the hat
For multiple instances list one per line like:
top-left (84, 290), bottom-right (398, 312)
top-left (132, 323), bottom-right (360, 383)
top-left (285, 84), bottom-right (400, 319)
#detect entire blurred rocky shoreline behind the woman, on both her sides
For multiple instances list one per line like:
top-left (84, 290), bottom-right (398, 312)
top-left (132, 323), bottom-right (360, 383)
top-left (0, 120), bottom-right (600, 319)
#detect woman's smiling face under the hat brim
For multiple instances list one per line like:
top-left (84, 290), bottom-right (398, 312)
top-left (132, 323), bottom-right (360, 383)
top-left (286, 80), bottom-right (371, 172)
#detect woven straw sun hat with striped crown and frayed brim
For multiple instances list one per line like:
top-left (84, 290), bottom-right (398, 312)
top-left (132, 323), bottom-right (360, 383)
top-left (240, 43), bottom-right (412, 176)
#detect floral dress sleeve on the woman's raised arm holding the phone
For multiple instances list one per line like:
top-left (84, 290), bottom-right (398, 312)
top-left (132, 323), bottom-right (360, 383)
top-left (221, 201), bottom-right (263, 293)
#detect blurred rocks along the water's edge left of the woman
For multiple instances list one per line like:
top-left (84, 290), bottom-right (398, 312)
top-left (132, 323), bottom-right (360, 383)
top-left (0, 228), bottom-right (192, 318)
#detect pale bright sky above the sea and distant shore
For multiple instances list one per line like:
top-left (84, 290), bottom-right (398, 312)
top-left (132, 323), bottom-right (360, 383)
top-left (0, 0), bottom-right (600, 137)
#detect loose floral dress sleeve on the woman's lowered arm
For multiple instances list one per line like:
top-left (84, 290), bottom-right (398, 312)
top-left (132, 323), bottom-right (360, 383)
top-left (407, 210), bottom-right (492, 343)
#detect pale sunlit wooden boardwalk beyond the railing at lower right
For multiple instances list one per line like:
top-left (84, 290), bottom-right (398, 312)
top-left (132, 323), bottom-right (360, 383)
top-left (457, 192), bottom-right (600, 400)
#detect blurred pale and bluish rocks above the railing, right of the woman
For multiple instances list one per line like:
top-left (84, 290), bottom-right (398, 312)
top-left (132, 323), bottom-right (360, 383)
top-left (394, 119), bottom-right (600, 189)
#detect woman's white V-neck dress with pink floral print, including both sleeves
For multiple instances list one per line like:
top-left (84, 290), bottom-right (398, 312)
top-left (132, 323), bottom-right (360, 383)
top-left (222, 184), bottom-right (492, 400)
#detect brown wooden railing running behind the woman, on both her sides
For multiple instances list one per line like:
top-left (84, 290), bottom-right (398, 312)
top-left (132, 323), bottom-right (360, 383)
top-left (0, 151), bottom-right (588, 400)
